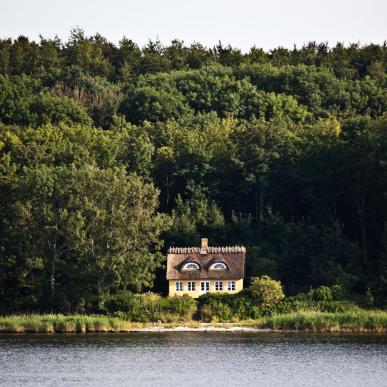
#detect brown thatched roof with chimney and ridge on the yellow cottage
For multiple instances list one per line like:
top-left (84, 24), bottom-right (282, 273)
top-left (167, 241), bottom-right (246, 280)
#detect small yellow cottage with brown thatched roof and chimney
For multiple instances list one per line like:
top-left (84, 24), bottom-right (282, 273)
top-left (167, 238), bottom-right (246, 298)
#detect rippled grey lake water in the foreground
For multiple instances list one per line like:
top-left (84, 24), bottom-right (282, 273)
top-left (0, 332), bottom-right (387, 387)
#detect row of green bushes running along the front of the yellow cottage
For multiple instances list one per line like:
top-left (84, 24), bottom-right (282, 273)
top-left (104, 282), bottom-right (361, 323)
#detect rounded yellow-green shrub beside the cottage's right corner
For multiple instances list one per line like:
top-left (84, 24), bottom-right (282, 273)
top-left (249, 275), bottom-right (285, 308)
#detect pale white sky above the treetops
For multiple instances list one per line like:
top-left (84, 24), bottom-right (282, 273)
top-left (0, 0), bottom-right (387, 51)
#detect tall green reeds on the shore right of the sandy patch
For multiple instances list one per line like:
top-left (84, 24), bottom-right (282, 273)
top-left (256, 310), bottom-right (387, 332)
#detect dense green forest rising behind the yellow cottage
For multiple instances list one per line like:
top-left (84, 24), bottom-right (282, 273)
top-left (0, 29), bottom-right (387, 314)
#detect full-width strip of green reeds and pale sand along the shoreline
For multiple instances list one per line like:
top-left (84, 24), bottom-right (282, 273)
top-left (0, 310), bottom-right (387, 333)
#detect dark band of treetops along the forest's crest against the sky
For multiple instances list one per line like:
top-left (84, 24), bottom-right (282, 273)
top-left (0, 28), bottom-right (387, 82)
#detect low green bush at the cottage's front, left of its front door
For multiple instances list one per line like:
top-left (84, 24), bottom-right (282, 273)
top-left (105, 291), bottom-right (196, 323)
